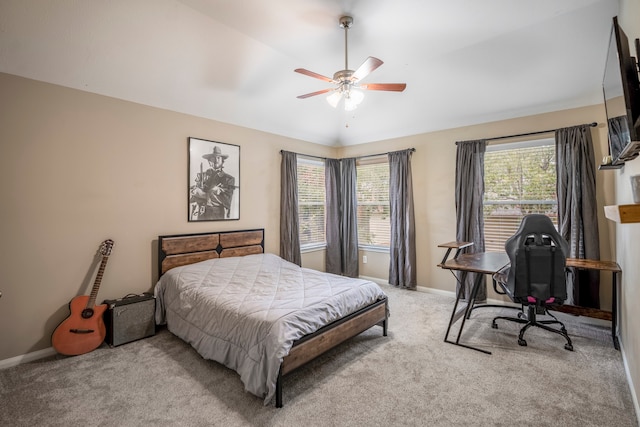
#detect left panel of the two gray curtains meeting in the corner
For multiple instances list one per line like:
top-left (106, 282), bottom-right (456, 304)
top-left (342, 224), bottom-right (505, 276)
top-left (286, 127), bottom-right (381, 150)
top-left (324, 159), bottom-right (342, 274)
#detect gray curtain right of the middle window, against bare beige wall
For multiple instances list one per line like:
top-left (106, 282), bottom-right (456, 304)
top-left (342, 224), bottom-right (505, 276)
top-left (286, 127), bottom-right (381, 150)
top-left (389, 150), bottom-right (417, 289)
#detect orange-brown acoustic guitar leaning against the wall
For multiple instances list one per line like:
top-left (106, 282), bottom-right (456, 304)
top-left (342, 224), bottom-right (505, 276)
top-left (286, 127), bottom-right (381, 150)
top-left (51, 239), bottom-right (113, 356)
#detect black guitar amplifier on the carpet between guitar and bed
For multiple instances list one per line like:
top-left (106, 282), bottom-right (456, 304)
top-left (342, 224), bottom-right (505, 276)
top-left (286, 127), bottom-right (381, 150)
top-left (104, 293), bottom-right (156, 347)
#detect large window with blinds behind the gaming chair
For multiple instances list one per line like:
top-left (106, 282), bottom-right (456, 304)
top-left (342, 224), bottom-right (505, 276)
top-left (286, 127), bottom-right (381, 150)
top-left (484, 138), bottom-right (558, 252)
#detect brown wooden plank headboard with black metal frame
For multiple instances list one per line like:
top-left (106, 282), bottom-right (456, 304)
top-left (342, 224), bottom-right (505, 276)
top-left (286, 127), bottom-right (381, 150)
top-left (158, 228), bottom-right (264, 277)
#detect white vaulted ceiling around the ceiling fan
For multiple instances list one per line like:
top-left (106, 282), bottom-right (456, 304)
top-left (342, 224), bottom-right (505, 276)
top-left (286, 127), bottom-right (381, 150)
top-left (0, 0), bottom-right (618, 146)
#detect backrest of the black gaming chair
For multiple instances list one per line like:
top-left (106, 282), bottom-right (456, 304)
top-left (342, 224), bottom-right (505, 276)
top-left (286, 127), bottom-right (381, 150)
top-left (505, 214), bottom-right (569, 304)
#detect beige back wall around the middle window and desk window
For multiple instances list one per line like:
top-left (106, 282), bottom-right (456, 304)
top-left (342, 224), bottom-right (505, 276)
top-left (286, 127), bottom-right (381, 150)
top-left (340, 105), bottom-right (614, 302)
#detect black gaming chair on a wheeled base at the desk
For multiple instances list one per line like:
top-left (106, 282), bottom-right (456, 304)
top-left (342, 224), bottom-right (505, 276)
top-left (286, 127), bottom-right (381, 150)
top-left (492, 214), bottom-right (573, 351)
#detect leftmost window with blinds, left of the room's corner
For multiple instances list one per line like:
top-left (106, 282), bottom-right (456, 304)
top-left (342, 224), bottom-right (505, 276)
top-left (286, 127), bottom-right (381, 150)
top-left (297, 156), bottom-right (326, 249)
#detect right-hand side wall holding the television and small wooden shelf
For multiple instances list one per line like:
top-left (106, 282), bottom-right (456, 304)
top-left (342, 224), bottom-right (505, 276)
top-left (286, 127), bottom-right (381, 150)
top-left (614, 0), bottom-right (640, 413)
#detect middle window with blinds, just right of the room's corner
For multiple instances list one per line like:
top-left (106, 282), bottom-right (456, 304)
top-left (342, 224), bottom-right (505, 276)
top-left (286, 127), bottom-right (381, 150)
top-left (356, 156), bottom-right (391, 248)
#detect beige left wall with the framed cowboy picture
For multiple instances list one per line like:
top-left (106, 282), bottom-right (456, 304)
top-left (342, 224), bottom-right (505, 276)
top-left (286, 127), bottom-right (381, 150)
top-left (0, 74), bottom-right (335, 361)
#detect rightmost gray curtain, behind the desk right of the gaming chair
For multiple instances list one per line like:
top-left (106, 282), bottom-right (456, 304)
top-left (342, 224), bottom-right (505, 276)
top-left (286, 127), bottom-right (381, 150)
top-left (555, 125), bottom-right (600, 308)
